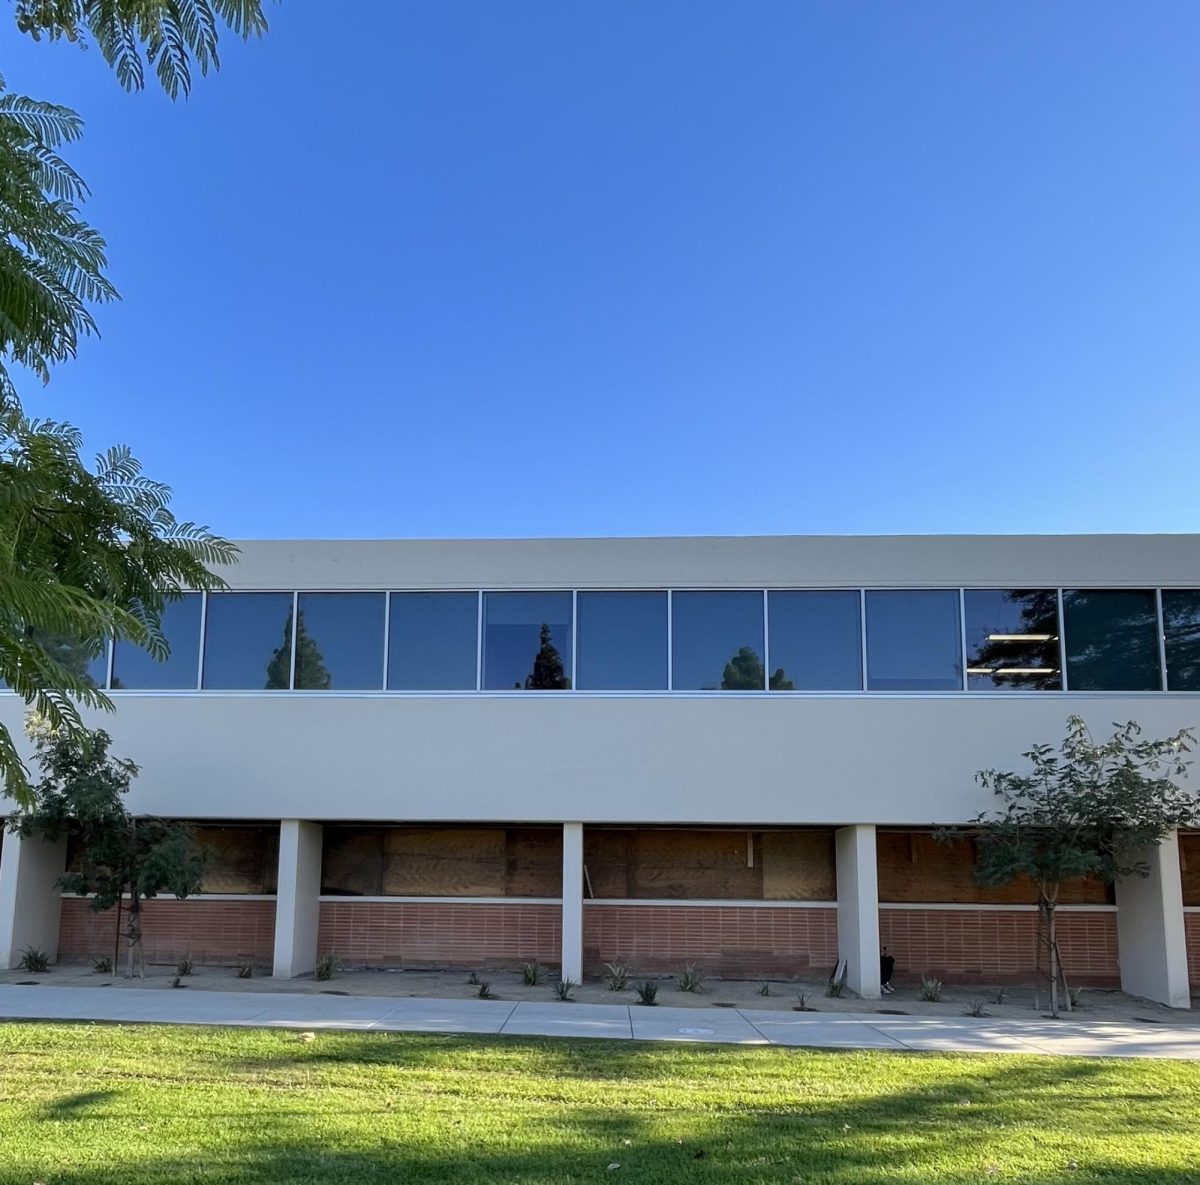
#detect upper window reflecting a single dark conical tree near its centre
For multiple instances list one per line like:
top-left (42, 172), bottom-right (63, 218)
top-left (484, 593), bottom-right (571, 691)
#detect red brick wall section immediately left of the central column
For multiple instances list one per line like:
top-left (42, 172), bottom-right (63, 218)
top-left (317, 901), bottom-right (563, 968)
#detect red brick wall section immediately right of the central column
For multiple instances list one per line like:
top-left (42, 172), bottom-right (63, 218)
top-left (583, 904), bottom-right (838, 978)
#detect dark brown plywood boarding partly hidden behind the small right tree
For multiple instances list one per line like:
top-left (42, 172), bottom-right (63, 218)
top-left (876, 831), bottom-right (1111, 906)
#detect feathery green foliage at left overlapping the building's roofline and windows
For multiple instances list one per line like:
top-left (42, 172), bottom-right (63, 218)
top-left (0, 405), bottom-right (238, 801)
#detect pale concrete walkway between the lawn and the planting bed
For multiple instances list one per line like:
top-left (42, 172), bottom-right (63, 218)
top-left (0, 985), bottom-right (1200, 1059)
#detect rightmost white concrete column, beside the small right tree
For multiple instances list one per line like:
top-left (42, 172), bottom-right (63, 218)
top-left (1116, 834), bottom-right (1192, 1007)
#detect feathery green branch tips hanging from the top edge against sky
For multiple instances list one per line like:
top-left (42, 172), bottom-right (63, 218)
top-left (14, 0), bottom-right (266, 98)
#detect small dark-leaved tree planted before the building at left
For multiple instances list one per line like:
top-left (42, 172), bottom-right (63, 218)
top-left (8, 716), bottom-right (204, 976)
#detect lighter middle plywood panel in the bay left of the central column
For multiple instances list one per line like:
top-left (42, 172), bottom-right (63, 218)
top-left (383, 828), bottom-right (508, 897)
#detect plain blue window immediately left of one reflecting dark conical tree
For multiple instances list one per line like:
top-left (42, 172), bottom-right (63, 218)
top-left (388, 593), bottom-right (479, 691)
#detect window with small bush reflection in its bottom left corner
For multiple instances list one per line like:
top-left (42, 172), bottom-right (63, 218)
top-left (767, 591), bottom-right (863, 691)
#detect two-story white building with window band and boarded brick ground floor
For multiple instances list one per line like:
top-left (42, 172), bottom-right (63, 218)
top-left (0, 536), bottom-right (1200, 1007)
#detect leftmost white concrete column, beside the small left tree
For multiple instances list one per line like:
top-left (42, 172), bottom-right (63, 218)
top-left (0, 831), bottom-right (67, 970)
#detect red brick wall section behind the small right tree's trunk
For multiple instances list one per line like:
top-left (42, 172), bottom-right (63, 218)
top-left (880, 909), bottom-right (1121, 987)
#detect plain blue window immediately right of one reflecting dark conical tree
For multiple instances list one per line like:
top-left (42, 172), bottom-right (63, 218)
top-left (577, 593), bottom-right (667, 691)
